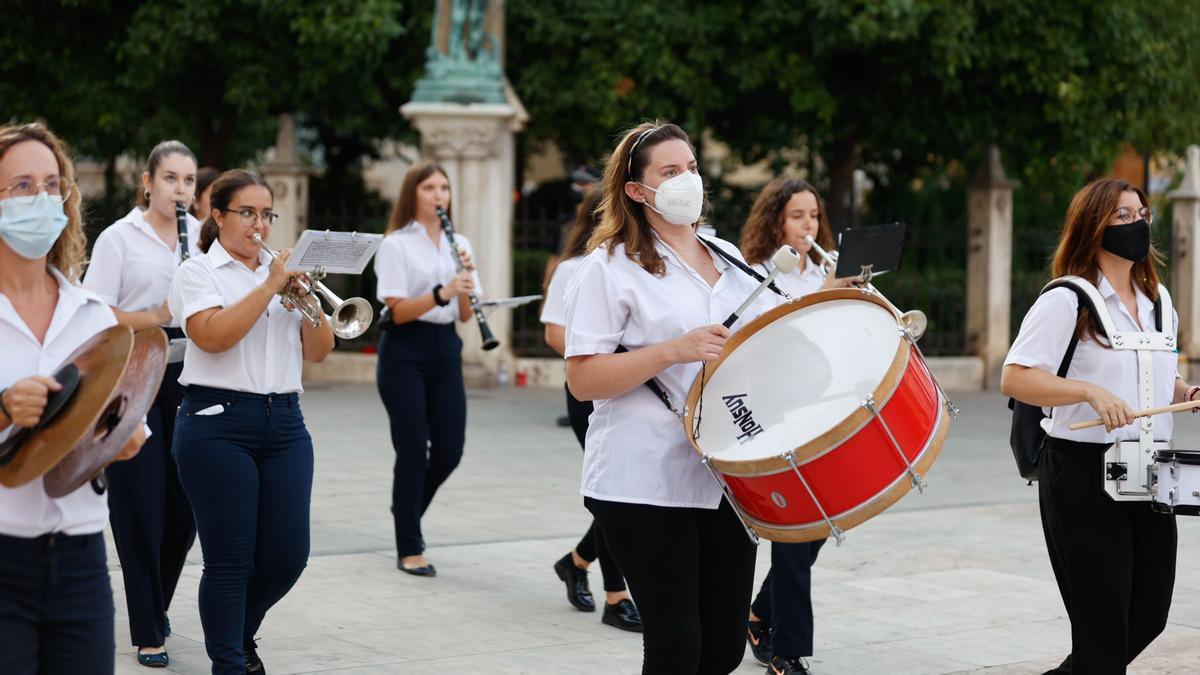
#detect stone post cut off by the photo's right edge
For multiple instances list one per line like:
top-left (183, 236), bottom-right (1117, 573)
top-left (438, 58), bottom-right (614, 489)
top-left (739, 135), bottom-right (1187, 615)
top-left (1168, 145), bottom-right (1200, 380)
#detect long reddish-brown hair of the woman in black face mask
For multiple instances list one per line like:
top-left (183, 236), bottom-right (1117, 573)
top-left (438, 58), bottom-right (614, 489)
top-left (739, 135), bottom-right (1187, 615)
top-left (1051, 178), bottom-right (1165, 340)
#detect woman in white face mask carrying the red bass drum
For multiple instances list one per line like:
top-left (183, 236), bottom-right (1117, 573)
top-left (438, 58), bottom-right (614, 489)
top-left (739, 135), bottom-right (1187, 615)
top-left (565, 123), bottom-right (775, 675)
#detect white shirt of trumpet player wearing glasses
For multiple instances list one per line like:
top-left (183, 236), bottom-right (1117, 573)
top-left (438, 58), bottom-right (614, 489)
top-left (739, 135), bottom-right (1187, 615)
top-left (170, 241), bottom-right (304, 394)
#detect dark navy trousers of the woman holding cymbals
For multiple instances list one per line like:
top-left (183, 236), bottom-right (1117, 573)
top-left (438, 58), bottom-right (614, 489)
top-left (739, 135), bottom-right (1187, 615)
top-left (0, 532), bottom-right (116, 675)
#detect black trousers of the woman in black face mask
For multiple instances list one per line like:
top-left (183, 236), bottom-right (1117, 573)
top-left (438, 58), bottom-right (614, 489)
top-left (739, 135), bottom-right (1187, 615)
top-left (1038, 438), bottom-right (1176, 675)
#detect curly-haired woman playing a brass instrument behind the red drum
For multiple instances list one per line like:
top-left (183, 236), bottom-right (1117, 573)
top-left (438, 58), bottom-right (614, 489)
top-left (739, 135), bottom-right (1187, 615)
top-left (739, 177), bottom-right (857, 675)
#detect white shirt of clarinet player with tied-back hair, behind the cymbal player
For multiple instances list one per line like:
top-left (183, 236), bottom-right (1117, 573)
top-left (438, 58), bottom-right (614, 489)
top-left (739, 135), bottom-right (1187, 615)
top-left (83, 208), bottom-right (200, 327)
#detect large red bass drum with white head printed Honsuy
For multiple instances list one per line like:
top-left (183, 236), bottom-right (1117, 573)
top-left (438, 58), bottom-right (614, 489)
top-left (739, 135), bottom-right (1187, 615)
top-left (684, 289), bottom-right (954, 542)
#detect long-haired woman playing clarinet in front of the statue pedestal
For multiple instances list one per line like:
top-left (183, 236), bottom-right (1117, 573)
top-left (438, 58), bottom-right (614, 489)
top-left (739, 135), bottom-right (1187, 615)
top-left (374, 157), bottom-right (481, 577)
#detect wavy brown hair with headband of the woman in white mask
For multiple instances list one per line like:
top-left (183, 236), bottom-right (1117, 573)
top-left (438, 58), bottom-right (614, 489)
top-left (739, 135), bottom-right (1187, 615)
top-left (588, 121), bottom-right (696, 276)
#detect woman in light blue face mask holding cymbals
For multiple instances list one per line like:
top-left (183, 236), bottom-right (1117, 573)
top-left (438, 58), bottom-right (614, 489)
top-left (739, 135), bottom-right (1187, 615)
top-left (0, 124), bottom-right (145, 675)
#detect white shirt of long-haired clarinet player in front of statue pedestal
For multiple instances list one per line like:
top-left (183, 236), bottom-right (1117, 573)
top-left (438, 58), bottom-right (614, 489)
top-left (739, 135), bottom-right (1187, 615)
top-left (374, 220), bottom-right (484, 323)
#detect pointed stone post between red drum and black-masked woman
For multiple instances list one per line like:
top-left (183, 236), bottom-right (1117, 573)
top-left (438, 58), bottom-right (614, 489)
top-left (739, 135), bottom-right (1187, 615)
top-left (967, 145), bottom-right (1018, 389)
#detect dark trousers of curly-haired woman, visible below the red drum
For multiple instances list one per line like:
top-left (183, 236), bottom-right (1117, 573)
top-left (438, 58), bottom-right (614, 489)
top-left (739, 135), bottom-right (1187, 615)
top-left (750, 539), bottom-right (826, 658)
